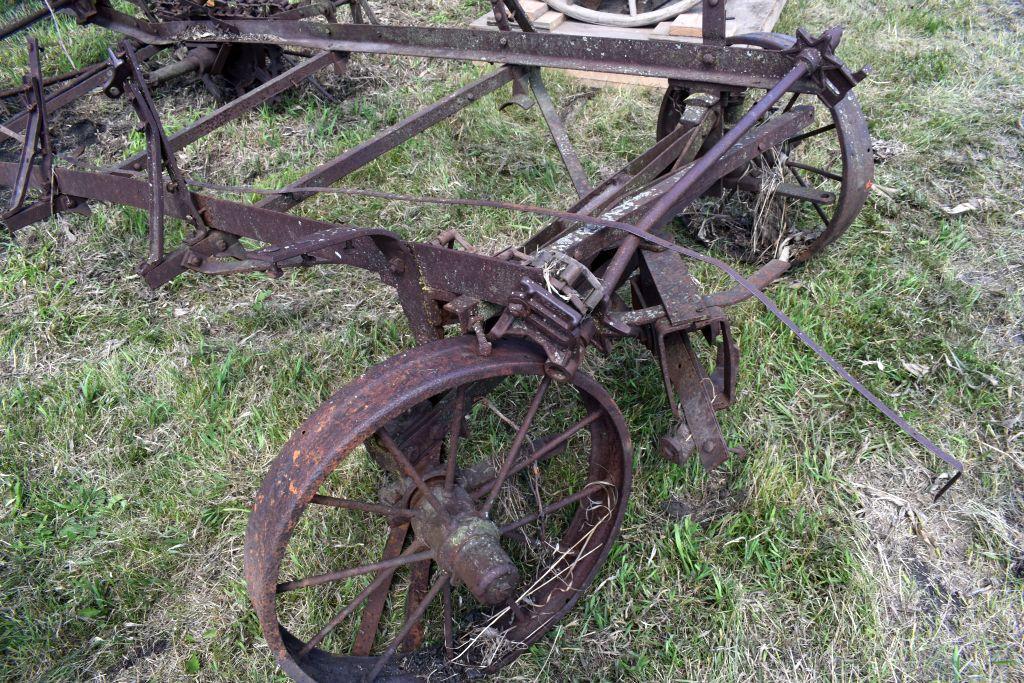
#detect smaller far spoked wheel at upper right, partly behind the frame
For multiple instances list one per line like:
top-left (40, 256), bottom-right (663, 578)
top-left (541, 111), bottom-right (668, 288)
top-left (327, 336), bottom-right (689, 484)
top-left (657, 33), bottom-right (873, 263)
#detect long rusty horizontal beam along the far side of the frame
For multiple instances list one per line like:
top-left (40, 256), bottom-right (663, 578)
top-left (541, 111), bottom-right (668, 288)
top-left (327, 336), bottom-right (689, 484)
top-left (77, 1), bottom-right (817, 92)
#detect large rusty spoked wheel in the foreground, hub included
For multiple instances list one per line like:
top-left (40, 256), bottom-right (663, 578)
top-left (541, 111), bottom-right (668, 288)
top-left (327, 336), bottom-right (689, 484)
top-left (245, 337), bottom-right (631, 681)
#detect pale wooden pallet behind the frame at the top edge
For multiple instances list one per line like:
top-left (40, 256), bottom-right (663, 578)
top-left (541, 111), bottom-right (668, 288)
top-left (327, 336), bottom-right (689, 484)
top-left (470, 0), bottom-right (785, 90)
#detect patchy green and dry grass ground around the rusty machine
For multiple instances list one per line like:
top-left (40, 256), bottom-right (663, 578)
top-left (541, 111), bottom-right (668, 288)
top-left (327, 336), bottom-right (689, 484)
top-left (0, 0), bottom-right (1024, 681)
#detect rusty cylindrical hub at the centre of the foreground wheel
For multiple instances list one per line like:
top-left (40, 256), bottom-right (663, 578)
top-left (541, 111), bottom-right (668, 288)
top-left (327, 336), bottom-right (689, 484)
top-left (413, 484), bottom-right (519, 605)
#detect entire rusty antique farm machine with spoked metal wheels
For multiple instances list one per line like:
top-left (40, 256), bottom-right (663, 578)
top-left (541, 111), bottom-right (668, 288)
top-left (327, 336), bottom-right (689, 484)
top-left (0, 0), bottom-right (962, 681)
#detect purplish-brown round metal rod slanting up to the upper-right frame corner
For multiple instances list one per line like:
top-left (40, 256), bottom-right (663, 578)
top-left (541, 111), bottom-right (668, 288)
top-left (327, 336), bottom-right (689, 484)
top-left (604, 60), bottom-right (808, 306)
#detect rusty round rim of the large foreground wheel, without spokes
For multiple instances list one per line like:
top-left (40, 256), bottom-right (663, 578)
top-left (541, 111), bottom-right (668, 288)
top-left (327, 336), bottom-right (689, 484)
top-left (245, 337), bottom-right (632, 681)
